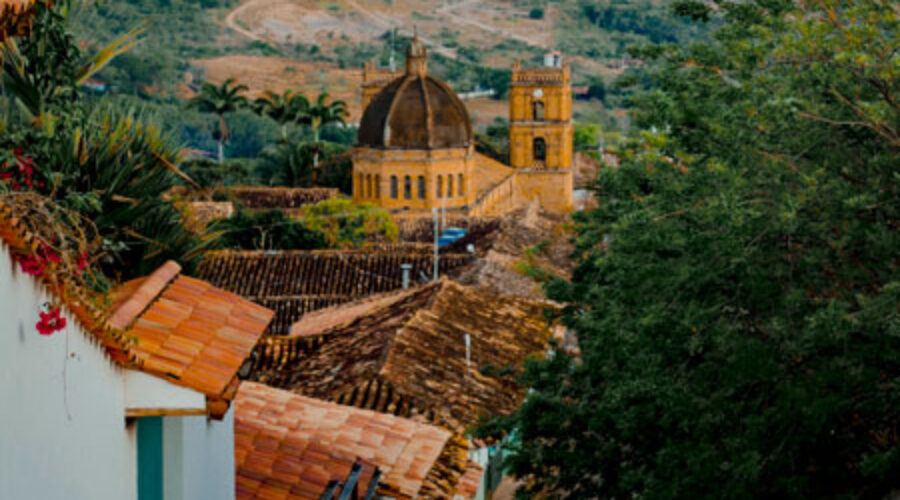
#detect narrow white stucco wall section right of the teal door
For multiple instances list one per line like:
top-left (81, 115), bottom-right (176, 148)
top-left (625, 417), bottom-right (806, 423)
top-left (163, 410), bottom-right (235, 500)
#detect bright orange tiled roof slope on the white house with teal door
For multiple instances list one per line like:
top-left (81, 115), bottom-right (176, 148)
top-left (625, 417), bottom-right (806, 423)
top-left (110, 262), bottom-right (274, 401)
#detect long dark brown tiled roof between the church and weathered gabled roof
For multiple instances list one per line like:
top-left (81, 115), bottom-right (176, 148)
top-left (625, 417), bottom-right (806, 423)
top-left (196, 249), bottom-right (472, 335)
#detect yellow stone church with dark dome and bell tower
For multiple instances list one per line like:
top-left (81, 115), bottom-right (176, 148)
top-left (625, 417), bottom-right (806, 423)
top-left (353, 37), bottom-right (574, 217)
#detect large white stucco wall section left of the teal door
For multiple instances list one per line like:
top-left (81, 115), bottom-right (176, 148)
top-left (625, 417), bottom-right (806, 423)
top-left (0, 243), bottom-right (137, 500)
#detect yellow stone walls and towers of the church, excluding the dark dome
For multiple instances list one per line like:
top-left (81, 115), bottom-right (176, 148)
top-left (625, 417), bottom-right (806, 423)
top-left (353, 46), bottom-right (574, 216)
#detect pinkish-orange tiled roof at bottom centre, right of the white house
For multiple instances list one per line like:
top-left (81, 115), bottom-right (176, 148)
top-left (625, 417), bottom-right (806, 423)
top-left (234, 382), bottom-right (467, 500)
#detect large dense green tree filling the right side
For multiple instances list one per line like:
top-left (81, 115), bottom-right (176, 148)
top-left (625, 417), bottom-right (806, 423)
top-left (483, 0), bottom-right (900, 498)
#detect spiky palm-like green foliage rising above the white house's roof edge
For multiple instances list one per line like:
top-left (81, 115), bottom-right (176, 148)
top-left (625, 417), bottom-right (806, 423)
top-left (0, 2), bottom-right (210, 277)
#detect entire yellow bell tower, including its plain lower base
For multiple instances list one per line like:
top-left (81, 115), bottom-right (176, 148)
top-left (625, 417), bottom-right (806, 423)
top-left (509, 52), bottom-right (575, 212)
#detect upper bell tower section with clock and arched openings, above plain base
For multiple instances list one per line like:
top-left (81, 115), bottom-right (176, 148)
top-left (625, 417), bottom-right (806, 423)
top-left (509, 51), bottom-right (574, 169)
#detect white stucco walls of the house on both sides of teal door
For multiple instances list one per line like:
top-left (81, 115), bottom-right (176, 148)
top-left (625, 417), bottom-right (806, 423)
top-left (0, 243), bottom-right (235, 500)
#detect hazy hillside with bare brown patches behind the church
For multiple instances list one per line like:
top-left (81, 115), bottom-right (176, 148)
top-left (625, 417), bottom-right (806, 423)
top-left (74, 0), bottom-right (698, 153)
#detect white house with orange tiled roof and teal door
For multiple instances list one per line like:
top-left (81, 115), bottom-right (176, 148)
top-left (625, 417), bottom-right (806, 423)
top-left (0, 203), bottom-right (273, 500)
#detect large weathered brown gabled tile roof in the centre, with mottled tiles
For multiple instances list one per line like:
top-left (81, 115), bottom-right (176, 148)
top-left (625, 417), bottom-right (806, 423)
top-left (253, 280), bottom-right (552, 429)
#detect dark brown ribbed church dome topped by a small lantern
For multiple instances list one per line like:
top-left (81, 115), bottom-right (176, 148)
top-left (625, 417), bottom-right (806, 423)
top-left (357, 37), bottom-right (472, 149)
